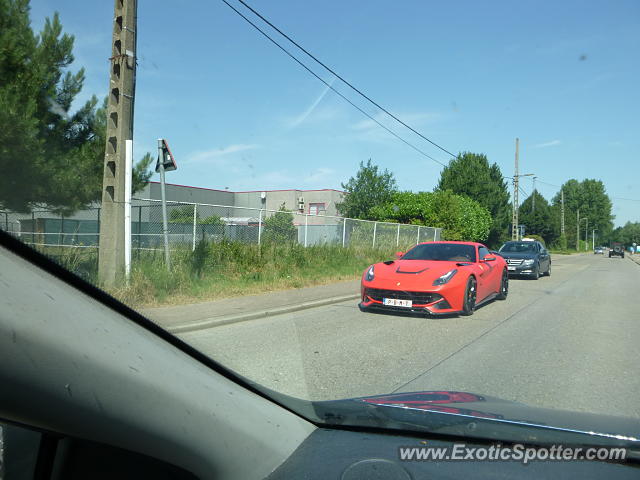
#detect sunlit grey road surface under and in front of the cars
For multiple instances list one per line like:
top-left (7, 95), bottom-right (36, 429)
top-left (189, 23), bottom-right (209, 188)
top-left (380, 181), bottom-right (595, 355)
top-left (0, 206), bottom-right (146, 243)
top-left (180, 254), bottom-right (640, 418)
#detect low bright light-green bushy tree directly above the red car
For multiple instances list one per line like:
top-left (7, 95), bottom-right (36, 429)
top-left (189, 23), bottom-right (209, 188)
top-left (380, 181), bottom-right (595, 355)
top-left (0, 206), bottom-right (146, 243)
top-left (371, 190), bottom-right (491, 242)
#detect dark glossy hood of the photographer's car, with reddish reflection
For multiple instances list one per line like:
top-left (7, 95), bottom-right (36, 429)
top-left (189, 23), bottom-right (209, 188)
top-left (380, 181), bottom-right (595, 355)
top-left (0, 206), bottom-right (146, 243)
top-left (272, 391), bottom-right (640, 451)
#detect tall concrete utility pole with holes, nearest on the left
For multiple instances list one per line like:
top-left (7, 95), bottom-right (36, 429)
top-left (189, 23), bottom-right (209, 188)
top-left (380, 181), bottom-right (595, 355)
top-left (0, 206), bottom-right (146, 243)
top-left (98, 0), bottom-right (137, 287)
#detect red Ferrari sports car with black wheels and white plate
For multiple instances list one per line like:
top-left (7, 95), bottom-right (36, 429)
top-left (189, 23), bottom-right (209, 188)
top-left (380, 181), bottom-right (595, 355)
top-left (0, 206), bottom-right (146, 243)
top-left (360, 242), bottom-right (509, 315)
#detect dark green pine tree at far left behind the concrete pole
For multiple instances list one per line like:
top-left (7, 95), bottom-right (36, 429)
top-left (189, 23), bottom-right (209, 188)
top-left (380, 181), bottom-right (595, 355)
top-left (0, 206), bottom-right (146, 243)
top-left (0, 0), bottom-right (151, 214)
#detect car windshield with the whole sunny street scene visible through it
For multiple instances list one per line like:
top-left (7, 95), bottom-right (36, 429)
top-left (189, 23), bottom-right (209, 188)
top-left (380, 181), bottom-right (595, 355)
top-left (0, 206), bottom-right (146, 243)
top-left (0, 0), bottom-right (640, 442)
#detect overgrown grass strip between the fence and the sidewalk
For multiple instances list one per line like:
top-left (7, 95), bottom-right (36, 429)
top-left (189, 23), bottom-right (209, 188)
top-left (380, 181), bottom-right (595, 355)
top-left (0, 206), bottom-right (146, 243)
top-left (111, 242), bottom-right (393, 306)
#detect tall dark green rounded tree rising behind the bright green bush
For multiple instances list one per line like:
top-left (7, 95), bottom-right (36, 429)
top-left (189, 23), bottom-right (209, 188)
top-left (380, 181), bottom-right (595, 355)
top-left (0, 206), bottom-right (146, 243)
top-left (436, 152), bottom-right (511, 246)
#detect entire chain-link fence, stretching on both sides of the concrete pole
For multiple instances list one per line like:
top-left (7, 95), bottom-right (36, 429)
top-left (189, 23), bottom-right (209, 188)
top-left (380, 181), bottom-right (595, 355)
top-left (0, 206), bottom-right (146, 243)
top-left (0, 198), bottom-right (441, 251)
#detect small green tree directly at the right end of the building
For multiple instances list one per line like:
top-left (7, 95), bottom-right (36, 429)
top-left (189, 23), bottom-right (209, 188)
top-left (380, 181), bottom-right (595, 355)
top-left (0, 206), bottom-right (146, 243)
top-left (337, 159), bottom-right (397, 220)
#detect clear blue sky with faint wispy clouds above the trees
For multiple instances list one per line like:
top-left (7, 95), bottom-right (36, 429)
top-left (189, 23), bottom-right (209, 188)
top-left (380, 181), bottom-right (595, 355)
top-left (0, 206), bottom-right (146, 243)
top-left (31, 0), bottom-right (640, 225)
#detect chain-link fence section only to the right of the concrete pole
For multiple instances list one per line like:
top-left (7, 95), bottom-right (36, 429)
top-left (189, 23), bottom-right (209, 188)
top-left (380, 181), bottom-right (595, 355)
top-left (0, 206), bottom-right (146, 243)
top-left (131, 199), bottom-right (440, 249)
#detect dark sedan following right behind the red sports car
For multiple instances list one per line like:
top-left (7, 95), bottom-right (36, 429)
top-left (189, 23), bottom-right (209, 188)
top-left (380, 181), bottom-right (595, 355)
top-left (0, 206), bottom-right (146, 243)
top-left (498, 240), bottom-right (551, 280)
